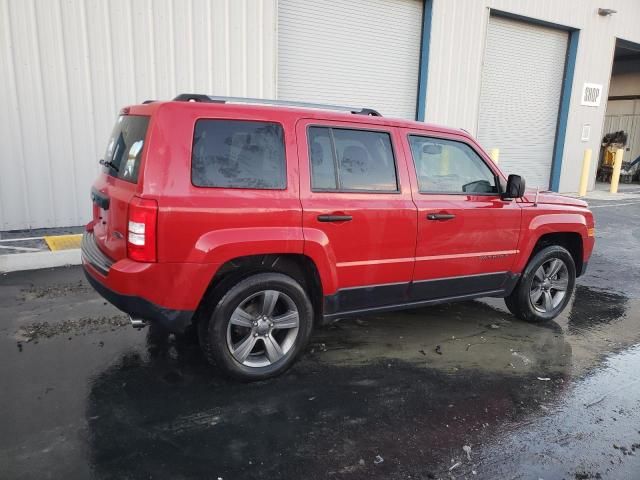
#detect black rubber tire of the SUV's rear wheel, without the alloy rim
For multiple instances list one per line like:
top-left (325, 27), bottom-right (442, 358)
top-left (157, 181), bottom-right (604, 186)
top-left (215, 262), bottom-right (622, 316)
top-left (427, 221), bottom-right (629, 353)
top-left (198, 273), bottom-right (313, 382)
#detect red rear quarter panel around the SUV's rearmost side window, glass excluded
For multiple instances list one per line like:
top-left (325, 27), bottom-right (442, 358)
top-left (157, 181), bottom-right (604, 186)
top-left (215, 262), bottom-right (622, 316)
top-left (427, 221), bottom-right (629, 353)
top-left (144, 103), bottom-right (303, 266)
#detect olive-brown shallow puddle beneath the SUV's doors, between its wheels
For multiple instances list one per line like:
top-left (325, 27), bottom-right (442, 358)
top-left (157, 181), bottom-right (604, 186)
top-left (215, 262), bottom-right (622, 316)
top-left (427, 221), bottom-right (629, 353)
top-left (312, 302), bottom-right (571, 374)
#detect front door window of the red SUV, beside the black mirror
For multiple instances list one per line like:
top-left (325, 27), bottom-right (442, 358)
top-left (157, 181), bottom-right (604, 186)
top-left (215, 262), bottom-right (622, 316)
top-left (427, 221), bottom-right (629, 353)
top-left (409, 135), bottom-right (498, 194)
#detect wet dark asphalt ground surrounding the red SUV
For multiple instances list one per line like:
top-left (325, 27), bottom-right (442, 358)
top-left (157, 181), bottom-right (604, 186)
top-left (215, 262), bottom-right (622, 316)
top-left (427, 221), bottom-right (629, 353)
top-left (0, 202), bottom-right (640, 480)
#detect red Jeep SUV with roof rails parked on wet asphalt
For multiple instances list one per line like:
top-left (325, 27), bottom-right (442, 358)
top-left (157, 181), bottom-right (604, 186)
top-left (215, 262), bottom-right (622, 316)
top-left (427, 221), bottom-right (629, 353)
top-left (82, 94), bottom-right (594, 380)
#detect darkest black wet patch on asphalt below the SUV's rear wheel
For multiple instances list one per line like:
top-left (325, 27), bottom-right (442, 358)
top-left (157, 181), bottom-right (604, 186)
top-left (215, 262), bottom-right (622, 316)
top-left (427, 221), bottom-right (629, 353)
top-left (76, 332), bottom-right (568, 478)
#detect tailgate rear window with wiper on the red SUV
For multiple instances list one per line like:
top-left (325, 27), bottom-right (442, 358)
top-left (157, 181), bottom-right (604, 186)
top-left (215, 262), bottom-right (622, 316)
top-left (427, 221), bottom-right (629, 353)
top-left (104, 115), bottom-right (149, 183)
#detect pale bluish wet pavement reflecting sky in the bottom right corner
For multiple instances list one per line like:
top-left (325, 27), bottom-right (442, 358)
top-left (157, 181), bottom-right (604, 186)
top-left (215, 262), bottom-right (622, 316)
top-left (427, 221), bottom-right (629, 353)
top-left (472, 346), bottom-right (640, 479)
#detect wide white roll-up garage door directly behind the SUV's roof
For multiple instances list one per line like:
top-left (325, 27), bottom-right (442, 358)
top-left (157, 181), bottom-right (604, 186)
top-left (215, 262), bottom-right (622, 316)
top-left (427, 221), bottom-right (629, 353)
top-left (278, 0), bottom-right (423, 119)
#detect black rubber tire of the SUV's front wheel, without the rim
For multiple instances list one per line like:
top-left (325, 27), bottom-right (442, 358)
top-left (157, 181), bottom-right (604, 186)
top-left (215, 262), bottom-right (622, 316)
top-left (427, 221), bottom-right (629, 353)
top-left (504, 245), bottom-right (576, 323)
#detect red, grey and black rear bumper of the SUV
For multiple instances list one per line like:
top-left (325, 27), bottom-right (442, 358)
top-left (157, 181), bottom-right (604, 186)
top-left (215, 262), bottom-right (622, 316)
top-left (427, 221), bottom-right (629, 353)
top-left (82, 232), bottom-right (202, 332)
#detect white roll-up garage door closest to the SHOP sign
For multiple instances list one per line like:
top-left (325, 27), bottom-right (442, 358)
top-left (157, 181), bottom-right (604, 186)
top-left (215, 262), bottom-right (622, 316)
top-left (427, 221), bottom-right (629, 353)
top-left (478, 16), bottom-right (568, 189)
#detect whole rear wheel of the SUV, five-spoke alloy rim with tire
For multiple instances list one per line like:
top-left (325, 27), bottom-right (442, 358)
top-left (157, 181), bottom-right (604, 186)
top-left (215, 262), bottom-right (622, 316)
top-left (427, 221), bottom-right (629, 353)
top-left (200, 273), bottom-right (313, 381)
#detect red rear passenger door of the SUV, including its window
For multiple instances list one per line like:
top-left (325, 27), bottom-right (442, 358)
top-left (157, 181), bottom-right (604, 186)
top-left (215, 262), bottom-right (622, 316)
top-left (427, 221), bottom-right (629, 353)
top-left (296, 119), bottom-right (417, 314)
